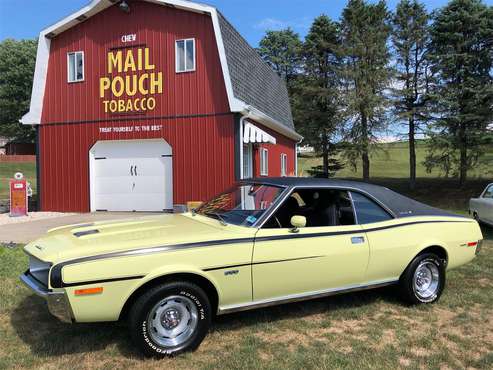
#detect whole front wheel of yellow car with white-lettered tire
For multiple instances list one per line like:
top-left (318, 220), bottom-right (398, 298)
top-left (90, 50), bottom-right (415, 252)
top-left (129, 282), bottom-right (212, 357)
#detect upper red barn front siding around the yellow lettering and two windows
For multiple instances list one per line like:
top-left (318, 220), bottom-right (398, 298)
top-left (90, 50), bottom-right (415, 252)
top-left (41, 2), bottom-right (229, 123)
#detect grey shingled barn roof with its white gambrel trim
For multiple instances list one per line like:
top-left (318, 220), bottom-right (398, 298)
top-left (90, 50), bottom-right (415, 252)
top-left (20, 0), bottom-right (302, 140)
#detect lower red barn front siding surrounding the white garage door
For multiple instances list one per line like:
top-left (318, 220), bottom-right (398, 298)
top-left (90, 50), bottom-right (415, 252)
top-left (40, 114), bottom-right (234, 212)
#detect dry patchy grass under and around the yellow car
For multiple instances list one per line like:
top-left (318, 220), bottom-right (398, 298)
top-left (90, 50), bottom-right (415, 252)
top-left (0, 184), bottom-right (493, 369)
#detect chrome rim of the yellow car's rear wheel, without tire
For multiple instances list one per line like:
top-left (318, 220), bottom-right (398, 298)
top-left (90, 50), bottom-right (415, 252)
top-left (413, 260), bottom-right (440, 302)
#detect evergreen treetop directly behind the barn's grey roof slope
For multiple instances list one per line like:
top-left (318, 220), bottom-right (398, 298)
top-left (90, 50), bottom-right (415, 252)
top-left (258, 28), bottom-right (302, 92)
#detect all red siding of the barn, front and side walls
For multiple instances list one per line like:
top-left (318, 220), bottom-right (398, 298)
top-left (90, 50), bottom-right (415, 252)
top-left (39, 0), bottom-right (295, 212)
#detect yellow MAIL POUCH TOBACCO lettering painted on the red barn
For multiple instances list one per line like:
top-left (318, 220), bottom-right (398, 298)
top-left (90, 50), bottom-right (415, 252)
top-left (99, 48), bottom-right (163, 113)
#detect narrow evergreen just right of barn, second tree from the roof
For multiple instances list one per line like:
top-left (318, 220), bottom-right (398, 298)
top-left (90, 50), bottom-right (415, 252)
top-left (295, 15), bottom-right (342, 177)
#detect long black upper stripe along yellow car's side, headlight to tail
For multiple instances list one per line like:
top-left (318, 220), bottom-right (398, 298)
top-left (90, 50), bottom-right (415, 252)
top-left (50, 221), bottom-right (468, 288)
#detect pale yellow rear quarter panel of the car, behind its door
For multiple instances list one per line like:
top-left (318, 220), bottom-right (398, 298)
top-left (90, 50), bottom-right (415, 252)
top-left (364, 216), bottom-right (482, 281)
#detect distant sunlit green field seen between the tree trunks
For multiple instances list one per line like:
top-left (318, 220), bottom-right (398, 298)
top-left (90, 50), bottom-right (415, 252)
top-left (298, 142), bottom-right (493, 179)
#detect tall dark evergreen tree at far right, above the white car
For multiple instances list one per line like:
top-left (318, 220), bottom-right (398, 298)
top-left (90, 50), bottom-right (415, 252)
top-left (425, 0), bottom-right (493, 186)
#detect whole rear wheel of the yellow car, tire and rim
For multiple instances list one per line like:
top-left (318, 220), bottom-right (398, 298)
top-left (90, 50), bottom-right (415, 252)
top-left (400, 253), bottom-right (445, 304)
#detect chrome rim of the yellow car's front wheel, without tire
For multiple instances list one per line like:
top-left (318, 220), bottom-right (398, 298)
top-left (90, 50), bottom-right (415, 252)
top-left (147, 295), bottom-right (198, 347)
